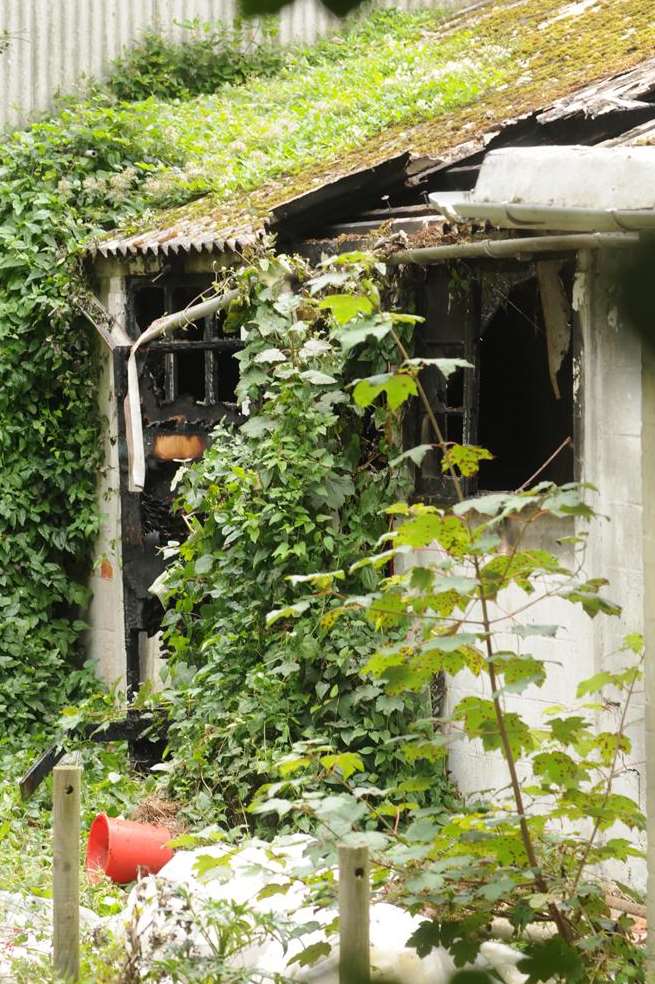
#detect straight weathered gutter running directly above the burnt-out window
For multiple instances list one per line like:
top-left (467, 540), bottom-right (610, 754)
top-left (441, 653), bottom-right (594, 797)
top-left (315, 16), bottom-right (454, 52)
top-left (388, 232), bottom-right (639, 265)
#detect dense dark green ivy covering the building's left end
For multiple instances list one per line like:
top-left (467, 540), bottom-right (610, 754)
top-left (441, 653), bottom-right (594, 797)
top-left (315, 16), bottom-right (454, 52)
top-left (0, 100), bottom-right (182, 730)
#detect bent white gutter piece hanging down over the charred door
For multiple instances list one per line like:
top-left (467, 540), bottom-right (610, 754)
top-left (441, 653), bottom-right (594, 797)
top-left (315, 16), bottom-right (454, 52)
top-left (123, 290), bottom-right (239, 492)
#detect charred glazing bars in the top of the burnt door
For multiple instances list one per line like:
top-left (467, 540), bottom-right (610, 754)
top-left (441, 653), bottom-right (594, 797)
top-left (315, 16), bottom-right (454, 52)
top-left (126, 272), bottom-right (244, 410)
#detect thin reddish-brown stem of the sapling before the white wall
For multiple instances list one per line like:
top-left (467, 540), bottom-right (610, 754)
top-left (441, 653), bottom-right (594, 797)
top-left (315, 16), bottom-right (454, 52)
top-left (391, 328), bottom-right (571, 942)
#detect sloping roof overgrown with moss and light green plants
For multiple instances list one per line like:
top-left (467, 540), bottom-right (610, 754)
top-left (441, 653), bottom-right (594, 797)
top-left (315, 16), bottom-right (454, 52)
top-left (98, 0), bottom-right (655, 255)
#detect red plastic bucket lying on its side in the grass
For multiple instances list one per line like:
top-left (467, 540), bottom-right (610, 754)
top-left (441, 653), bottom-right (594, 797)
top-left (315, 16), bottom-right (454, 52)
top-left (86, 813), bottom-right (174, 885)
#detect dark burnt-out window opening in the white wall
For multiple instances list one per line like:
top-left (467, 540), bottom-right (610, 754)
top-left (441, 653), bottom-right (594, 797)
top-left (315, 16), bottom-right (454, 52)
top-left (406, 261), bottom-right (574, 502)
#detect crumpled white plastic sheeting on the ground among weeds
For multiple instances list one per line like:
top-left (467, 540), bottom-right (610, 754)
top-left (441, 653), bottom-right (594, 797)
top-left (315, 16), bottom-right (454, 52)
top-left (113, 834), bottom-right (540, 984)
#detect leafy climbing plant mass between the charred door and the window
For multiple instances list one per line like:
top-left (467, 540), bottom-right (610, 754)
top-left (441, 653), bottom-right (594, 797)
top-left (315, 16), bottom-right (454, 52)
top-left (156, 252), bottom-right (454, 823)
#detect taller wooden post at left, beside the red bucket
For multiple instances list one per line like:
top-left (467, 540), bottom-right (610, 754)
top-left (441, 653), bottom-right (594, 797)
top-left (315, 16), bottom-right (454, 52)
top-left (52, 756), bottom-right (82, 981)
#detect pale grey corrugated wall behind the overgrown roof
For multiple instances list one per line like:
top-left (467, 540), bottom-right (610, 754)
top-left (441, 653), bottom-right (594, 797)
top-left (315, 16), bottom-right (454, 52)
top-left (0, 0), bottom-right (472, 126)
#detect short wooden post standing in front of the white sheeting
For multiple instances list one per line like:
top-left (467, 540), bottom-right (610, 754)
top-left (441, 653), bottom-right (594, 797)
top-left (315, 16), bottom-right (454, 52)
top-left (338, 844), bottom-right (371, 984)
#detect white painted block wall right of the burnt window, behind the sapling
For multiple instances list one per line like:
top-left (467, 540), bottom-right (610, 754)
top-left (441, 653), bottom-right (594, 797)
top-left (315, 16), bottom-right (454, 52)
top-left (444, 244), bottom-right (646, 889)
